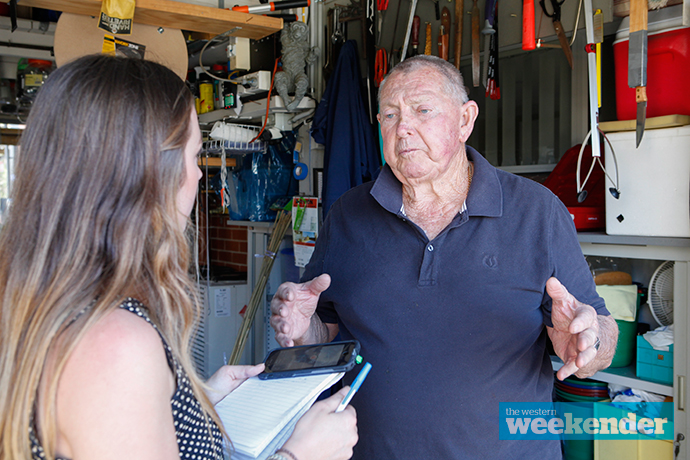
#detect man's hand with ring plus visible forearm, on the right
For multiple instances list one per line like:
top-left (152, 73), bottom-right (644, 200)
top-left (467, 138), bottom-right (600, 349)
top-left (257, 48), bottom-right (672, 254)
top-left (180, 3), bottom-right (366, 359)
top-left (546, 278), bottom-right (618, 380)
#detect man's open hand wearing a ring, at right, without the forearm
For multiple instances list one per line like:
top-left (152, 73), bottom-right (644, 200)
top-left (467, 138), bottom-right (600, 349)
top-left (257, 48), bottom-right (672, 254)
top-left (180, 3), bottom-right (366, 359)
top-left (546, 278), bottom-right (599, 380)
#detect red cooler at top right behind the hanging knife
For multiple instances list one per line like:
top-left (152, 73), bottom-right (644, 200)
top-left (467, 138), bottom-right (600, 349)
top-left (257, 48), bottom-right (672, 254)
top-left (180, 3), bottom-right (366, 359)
top-left (613, 5), bottom-right (690, 120)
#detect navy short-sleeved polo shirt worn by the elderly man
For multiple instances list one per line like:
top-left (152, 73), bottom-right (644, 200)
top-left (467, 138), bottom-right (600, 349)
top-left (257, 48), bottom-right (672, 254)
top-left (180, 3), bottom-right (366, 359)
top-left (303, 147), bottom-right (608, 460)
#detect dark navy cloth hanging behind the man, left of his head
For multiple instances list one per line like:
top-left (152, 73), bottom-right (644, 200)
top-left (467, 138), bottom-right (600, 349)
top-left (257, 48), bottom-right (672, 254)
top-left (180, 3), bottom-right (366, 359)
top-left (311, 40), bottom-right (381, 216)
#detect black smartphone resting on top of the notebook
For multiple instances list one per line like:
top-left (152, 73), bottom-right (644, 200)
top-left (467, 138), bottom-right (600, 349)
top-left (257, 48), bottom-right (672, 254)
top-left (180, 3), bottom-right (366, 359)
top-left (265, 342), bottom-right (356, 372)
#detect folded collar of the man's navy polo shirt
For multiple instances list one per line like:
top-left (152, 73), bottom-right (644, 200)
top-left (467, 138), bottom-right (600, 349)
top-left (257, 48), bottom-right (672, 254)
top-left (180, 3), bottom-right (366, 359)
top-left (370, 146), bottom-right (503, 217)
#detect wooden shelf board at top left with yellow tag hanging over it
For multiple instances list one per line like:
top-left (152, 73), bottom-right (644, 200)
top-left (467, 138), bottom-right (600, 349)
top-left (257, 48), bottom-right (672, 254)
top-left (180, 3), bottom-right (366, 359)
top-left (5, 0), bottom-right (283, 40)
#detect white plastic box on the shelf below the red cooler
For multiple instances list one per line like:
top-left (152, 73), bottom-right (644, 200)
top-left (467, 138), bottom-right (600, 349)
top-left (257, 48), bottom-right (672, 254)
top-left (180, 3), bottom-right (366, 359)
top-left (604, 125), bottom-right (690, 238)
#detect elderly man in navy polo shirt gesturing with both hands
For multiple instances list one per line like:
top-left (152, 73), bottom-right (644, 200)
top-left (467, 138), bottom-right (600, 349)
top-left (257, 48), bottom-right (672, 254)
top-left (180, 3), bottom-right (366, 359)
top-left (271, 56), bottom-right (618, 460)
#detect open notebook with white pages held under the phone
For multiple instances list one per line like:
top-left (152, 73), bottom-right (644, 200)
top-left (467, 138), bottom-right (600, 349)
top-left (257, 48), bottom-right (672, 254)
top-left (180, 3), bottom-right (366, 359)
top-left (216, 373), bottom-right (344, 460)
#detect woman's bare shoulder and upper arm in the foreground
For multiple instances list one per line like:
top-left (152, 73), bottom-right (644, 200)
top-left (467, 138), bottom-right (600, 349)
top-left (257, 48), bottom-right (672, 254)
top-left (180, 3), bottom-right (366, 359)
top-left (57, 308), bottom-right (177, 458)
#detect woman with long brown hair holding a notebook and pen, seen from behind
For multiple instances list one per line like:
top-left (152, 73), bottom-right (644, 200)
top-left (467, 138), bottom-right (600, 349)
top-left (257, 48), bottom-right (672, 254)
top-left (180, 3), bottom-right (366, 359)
top-left (0, 55), bottom-right (357, 460)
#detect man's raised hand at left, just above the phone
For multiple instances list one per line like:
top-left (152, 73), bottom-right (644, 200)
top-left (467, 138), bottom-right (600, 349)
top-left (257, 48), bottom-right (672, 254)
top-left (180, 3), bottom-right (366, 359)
top-left (271, 273), bottom-right (331, 347)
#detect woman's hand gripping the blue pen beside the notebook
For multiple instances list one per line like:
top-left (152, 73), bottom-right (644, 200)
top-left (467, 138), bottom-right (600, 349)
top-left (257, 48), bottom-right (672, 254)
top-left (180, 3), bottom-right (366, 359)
top-left (283, 387), bottom-right (359, 460)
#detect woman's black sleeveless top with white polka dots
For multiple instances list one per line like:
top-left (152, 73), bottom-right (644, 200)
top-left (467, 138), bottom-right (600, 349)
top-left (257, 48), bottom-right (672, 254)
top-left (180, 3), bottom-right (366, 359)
top-left (29, 298), bottom-right (223, 460)
